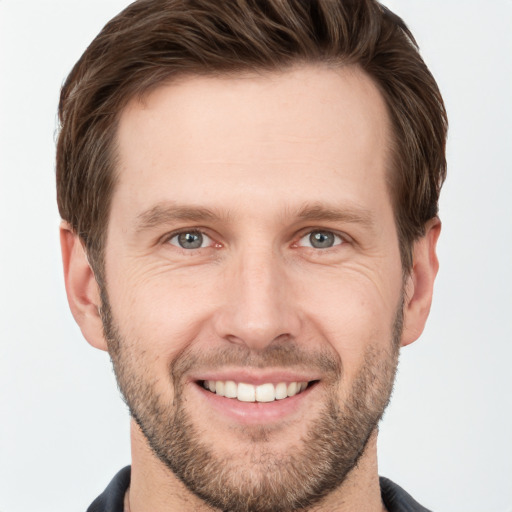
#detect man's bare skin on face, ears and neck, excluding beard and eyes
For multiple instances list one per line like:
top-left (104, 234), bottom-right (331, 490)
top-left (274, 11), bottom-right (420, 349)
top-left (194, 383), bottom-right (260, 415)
top-left (61, 65), bottom-right (440, 512)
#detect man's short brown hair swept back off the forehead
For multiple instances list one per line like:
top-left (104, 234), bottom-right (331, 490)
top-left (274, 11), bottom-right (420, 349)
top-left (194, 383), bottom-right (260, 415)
top-left (57, 0), bottom-right (447, 284)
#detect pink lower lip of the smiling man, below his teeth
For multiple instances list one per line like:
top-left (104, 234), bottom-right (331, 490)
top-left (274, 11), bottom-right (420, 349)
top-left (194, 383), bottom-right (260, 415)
top-left (194, 383), bottom-right (316, 425)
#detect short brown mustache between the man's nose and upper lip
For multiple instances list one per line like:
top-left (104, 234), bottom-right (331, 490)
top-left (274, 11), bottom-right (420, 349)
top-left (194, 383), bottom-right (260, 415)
top-left (169, 341), bottom-right (342, 385)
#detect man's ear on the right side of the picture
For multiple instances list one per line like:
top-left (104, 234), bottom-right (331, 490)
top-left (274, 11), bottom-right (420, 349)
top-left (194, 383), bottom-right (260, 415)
top-left (402, 217), bottom-right (441, 347)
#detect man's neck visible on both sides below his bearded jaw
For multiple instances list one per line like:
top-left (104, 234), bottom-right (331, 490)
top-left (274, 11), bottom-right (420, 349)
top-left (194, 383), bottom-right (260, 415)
top-left (125, 420), bottom-right (385, 512)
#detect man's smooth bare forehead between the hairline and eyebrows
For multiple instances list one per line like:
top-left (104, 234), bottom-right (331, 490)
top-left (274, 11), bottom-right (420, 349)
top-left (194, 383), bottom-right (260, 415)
top-left (113, 65), bottom-right (390, 222)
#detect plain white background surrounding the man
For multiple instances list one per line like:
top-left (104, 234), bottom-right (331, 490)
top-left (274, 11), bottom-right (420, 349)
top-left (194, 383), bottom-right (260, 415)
top-left (0, 0), bottom-right (512, 512)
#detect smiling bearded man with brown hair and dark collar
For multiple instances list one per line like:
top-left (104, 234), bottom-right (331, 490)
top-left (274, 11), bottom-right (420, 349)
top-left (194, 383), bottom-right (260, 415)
top-left (57, 0), bottom-right (447, 512)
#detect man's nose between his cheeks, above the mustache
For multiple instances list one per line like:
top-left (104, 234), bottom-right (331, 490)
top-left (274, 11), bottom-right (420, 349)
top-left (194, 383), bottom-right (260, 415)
top-left (215, 249), bottom-right (301, 351)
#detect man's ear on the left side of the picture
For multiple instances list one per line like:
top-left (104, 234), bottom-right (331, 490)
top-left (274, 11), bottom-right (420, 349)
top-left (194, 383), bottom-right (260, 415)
top-left (60, 221), bottom-right (107, 350)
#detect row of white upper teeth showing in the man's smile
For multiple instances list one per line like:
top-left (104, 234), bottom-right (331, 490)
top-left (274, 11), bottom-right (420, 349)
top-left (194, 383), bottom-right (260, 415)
top-left (203, 380), bottom-right (308, 402)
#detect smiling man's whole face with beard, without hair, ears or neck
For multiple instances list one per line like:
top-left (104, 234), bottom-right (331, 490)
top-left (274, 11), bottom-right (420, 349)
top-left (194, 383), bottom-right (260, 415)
top-left (103, 66), bottom-right (403, 511)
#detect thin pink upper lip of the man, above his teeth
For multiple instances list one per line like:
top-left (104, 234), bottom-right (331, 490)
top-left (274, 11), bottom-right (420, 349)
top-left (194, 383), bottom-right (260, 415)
top-left (190, 368), bottom-right (320, 386)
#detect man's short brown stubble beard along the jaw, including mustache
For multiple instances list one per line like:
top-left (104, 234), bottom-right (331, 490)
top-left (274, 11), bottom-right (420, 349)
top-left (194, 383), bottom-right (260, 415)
top-left (102, 294), bottom-right (403, 512)
